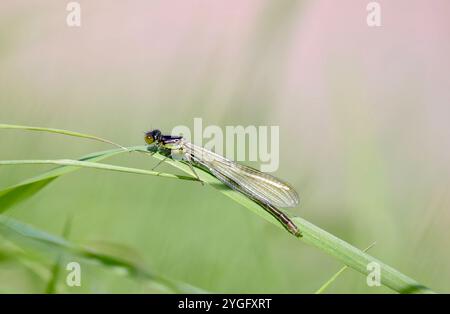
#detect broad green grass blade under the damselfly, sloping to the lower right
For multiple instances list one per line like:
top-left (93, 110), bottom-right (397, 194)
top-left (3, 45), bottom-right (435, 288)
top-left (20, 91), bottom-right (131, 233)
top-left (141, 150), bottom-right (433, 293)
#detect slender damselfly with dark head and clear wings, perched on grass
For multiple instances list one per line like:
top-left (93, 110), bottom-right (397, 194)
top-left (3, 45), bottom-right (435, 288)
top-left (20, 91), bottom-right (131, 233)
top-left (145, 130), bottom-right (301, 237)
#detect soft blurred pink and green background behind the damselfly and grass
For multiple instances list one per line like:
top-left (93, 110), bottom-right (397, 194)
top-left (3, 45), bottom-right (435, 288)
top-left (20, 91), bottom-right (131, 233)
top-left (0, 0), bottom-right (450, 293)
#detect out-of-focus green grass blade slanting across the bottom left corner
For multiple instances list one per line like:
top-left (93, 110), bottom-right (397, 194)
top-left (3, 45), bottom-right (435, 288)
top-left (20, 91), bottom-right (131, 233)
top-left (0, 215), bottom-right (205, 293)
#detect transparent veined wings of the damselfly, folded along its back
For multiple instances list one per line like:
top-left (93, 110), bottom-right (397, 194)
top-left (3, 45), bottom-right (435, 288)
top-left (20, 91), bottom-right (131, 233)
top-left (183, 142), bottom-right (299, 207)
